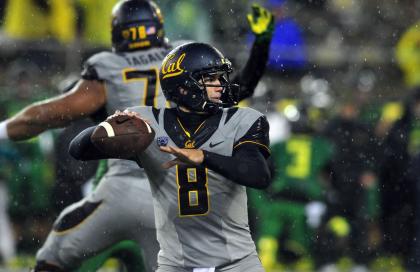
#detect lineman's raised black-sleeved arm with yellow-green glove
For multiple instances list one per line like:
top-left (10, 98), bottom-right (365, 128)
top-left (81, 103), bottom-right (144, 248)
top-left (233, 4), bottom-right (274, 101)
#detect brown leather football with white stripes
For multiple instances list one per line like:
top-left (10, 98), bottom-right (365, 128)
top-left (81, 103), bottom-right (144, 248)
top-left (91, 115), bottom-right (155, 158)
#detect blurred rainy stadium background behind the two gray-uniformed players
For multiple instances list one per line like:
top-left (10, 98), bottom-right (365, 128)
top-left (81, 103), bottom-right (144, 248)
top-left (0, 0), bottom-right (420, 271)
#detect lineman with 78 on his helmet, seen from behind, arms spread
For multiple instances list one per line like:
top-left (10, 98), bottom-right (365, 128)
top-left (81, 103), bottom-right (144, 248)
top-left (0, 0), bottom-right (273, 271)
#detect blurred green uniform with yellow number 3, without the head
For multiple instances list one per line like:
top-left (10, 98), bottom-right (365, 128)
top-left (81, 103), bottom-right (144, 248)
top-left (251, 134), bottom-right (333, 272)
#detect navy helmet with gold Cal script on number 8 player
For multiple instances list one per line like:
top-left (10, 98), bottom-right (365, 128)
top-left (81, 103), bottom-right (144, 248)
top-left (159, 42), bottom-right (239, 113)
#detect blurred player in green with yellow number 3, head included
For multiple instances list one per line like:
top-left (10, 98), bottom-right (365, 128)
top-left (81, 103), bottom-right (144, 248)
top-left (250, 103), bottom-right (333, 272)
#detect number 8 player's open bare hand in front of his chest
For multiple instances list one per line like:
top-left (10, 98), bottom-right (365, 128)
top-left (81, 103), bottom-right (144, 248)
top-left (160, 146), bottom-right (204, 169)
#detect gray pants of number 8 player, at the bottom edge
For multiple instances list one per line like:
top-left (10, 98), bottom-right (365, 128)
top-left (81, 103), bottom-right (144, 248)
top-left (156, 253), bottom-right (265, 272)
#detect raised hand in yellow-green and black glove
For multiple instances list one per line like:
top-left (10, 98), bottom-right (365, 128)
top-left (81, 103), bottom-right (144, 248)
top-left (247, 4), bottom-right (274, 39)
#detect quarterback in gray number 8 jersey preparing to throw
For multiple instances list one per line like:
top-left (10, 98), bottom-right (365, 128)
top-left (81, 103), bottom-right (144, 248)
top-left (70, 43), bottom-right (272, 272)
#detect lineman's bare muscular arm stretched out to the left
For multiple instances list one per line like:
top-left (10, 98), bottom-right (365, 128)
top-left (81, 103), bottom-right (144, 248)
top-left (0, 79), bottom-right (106, 141)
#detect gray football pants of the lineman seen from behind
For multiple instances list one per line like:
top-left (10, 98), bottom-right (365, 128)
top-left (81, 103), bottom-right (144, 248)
top-left (36, 176), bottom-right (159, 271)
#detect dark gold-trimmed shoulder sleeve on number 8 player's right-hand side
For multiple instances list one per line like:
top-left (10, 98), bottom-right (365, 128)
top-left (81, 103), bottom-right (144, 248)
top-left (233, 116), bottom-right (270, 158)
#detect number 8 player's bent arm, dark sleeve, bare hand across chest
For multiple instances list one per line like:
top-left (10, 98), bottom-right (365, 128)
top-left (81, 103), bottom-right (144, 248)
top-left (160, 117), bottom-right (274, 189)
